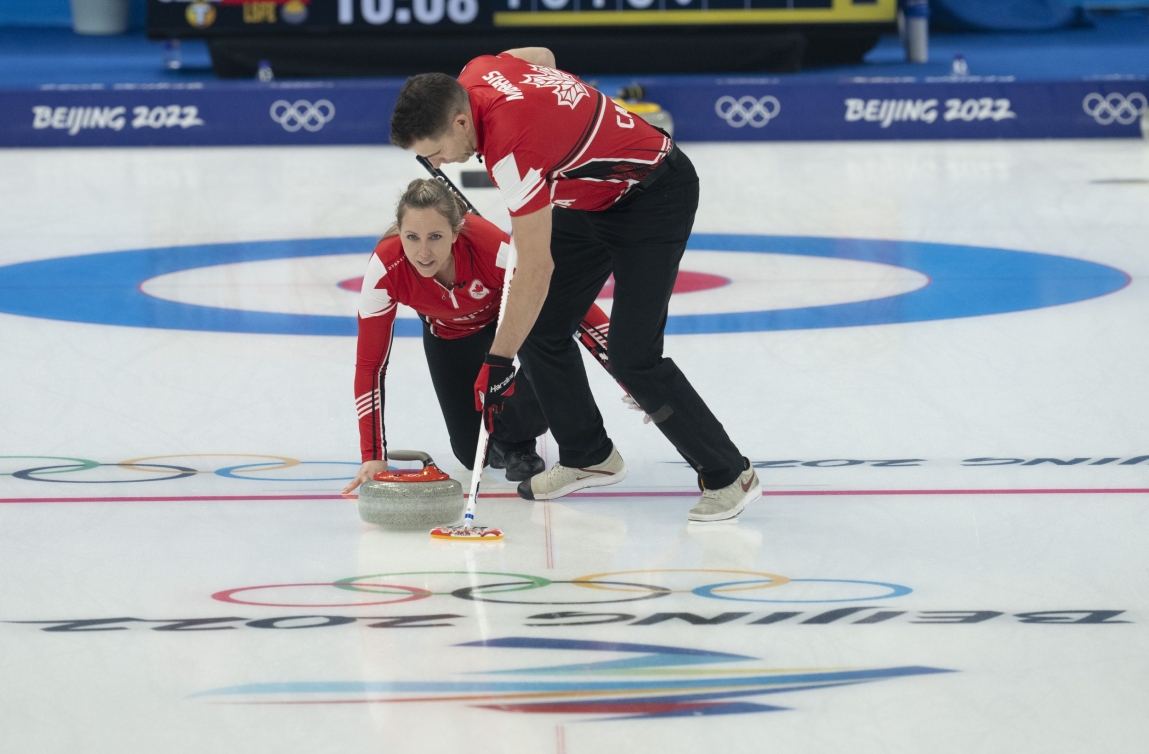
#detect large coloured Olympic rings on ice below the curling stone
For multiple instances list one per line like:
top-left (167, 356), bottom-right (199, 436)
top-left (211, 568), bottom-right (913, 607)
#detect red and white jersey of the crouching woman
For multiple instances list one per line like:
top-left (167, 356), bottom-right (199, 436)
top-left (355, 215), bottom-right (510, 461)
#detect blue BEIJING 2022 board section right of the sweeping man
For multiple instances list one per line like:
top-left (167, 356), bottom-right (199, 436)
top-left (643, 77), bottom-right (1149, 141)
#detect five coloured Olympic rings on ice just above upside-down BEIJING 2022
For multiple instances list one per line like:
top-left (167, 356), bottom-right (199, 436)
top-left (211, 568), bottom-right (913, 607)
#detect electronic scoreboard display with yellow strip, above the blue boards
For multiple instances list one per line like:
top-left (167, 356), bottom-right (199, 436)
top-left (147, 0), bottom-right (897, 38)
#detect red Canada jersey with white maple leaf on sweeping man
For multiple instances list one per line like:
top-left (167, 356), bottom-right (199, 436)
top-left (458, 53), bottom-right (672, 216)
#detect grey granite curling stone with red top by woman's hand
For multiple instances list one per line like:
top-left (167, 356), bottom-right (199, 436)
top-left (358, 451), bottom-right (466, 529)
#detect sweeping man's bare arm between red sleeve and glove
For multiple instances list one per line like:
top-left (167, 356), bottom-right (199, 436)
top-left (491, 205), bottom-right (555, 359)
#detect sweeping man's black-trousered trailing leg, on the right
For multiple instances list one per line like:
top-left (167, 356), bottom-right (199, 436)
top-left (594, 150), bottom-right (745, 490)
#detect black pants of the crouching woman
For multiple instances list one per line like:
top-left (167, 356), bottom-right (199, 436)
top-left (423, 319), bottom-right (546, 469)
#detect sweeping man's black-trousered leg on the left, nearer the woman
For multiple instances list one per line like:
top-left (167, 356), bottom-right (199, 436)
top-left (519, 203), bottom-right (614, 468)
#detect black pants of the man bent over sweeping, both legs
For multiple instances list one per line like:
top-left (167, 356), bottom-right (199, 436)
top-left (519, 152), bottom-right (743, 490)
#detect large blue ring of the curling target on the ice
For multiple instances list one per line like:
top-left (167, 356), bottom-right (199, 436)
top-left (0, 233), bottom-right (1129, 336)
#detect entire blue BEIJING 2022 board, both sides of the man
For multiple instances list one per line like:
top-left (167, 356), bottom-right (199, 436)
top-left (0, 76), bottom-right (1149, 147)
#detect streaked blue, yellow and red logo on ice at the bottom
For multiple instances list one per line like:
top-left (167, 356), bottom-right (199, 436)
top-left (193, 637), bottom-right (953, 720)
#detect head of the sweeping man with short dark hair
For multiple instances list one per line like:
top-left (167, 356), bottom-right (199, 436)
top-left (391, 74), bottom-right (477, 168)
